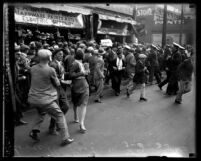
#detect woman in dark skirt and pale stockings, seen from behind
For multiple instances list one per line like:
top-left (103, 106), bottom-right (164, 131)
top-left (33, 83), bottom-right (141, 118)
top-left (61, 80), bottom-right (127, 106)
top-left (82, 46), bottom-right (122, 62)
top-left (70, 49), bottom-right (89, 133)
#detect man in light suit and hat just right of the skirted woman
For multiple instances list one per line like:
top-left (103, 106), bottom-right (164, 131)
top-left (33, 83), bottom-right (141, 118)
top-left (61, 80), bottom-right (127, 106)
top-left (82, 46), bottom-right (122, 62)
top-left (94, 48), bottom-right (105, 103)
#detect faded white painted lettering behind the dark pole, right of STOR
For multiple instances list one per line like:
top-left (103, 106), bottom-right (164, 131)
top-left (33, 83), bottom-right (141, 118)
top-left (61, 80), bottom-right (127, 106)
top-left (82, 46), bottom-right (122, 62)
top-left (154, 8), bottom-right (184, 24)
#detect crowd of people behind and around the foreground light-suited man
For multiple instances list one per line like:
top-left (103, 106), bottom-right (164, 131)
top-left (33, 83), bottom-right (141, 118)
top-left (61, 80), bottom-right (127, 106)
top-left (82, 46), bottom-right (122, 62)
top-left (15, 29), bottom-right (194, 145)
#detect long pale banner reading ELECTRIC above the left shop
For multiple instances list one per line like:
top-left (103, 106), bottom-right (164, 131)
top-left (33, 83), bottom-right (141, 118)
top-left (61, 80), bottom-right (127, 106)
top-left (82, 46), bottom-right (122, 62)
top-left (15, 7), bottom-right (84, 28)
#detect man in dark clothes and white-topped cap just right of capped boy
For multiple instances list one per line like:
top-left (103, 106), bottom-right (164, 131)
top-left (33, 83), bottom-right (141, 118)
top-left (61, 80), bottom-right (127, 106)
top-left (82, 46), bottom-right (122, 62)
top-left (147, 44), bottom-right (161, 84)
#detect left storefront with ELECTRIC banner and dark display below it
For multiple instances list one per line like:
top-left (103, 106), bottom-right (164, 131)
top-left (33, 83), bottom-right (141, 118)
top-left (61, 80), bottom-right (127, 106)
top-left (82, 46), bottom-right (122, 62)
top-left (15, 4), bottom-right (90, 44)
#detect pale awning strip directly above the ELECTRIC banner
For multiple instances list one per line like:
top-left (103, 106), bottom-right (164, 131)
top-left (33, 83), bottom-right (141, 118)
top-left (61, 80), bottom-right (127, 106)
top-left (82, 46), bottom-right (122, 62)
top-left (19, 3), bottom-right (91, 15)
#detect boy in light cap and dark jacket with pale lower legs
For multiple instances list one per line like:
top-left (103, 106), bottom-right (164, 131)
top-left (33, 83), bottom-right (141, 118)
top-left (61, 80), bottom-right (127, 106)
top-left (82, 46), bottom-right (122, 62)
top-left (133, 54), bottom-right (149, 101)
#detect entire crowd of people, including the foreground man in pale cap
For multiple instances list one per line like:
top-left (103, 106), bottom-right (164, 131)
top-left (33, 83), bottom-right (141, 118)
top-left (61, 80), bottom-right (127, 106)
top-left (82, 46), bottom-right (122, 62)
top-left (15, 31), bottom-right (194, 145)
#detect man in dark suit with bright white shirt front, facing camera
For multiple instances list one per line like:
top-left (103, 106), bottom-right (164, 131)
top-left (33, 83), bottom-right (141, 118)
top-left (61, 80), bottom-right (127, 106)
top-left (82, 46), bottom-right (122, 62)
top-left (111, 48), bottom-right (125, 96)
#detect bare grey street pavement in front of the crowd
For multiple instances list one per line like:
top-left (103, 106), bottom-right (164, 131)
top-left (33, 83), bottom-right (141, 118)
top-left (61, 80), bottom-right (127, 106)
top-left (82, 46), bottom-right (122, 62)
top-left (14, 75), bottom-right (196, 157)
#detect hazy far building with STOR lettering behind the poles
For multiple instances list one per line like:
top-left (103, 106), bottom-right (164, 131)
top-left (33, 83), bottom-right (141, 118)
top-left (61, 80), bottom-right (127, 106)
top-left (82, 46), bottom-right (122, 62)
top-left (136, 5), bottom-right (193, 44)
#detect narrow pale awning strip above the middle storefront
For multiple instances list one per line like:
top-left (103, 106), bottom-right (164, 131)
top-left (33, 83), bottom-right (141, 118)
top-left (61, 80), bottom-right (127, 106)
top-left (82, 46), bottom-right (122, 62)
top-left (99, 14), bottom-right (137, 25)
